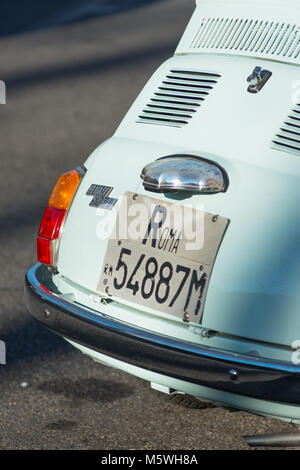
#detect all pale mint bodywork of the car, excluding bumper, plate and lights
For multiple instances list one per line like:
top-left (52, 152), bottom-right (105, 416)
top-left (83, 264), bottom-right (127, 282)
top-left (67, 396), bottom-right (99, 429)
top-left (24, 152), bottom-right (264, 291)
top-left (25, 0), bottom-right (300, 423)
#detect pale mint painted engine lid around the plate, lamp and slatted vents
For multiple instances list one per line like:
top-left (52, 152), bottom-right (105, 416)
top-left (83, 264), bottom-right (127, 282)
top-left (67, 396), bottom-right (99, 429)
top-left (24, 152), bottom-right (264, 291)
top-left (58, 52), bottom-right (300, 346)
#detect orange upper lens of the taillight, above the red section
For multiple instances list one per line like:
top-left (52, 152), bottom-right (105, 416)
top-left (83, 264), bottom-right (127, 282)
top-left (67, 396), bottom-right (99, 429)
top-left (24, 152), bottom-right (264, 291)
top-left (48, 170), bottom-right (82, 210)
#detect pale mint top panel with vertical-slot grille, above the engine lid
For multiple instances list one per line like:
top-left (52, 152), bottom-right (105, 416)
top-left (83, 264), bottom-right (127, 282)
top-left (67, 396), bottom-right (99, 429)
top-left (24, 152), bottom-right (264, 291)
top-left (175, 0), bottom-right (300, 65)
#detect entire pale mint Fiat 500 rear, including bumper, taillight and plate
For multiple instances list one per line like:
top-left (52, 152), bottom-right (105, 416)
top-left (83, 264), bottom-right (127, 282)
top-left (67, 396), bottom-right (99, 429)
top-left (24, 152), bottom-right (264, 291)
top-left (25, 0), bottom-right (300, 423)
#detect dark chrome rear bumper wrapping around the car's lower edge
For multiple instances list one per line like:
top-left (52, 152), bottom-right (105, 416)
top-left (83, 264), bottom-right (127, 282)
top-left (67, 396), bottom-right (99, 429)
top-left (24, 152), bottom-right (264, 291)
top-left (25, 264), bottom-right (300, 405)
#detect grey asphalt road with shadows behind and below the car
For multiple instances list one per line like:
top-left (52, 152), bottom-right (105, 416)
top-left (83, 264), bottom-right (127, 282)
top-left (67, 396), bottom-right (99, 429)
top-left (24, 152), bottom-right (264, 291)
top-left (0, 0), bottom-right (294, 450)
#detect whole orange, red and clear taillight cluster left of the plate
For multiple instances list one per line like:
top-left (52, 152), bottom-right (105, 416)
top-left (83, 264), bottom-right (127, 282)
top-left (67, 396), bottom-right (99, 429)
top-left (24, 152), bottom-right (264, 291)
top-left (37, 168), bottom-right (85, 267)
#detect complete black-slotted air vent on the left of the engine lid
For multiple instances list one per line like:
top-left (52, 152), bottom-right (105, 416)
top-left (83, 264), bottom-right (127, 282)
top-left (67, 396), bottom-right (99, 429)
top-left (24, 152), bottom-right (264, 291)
top-left (137, 69), bottom-right (221, 127)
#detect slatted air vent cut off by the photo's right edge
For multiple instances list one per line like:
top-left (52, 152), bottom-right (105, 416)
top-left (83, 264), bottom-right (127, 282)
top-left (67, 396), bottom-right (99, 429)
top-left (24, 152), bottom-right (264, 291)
top-left (272, 104), bottom-right (300, 156)
